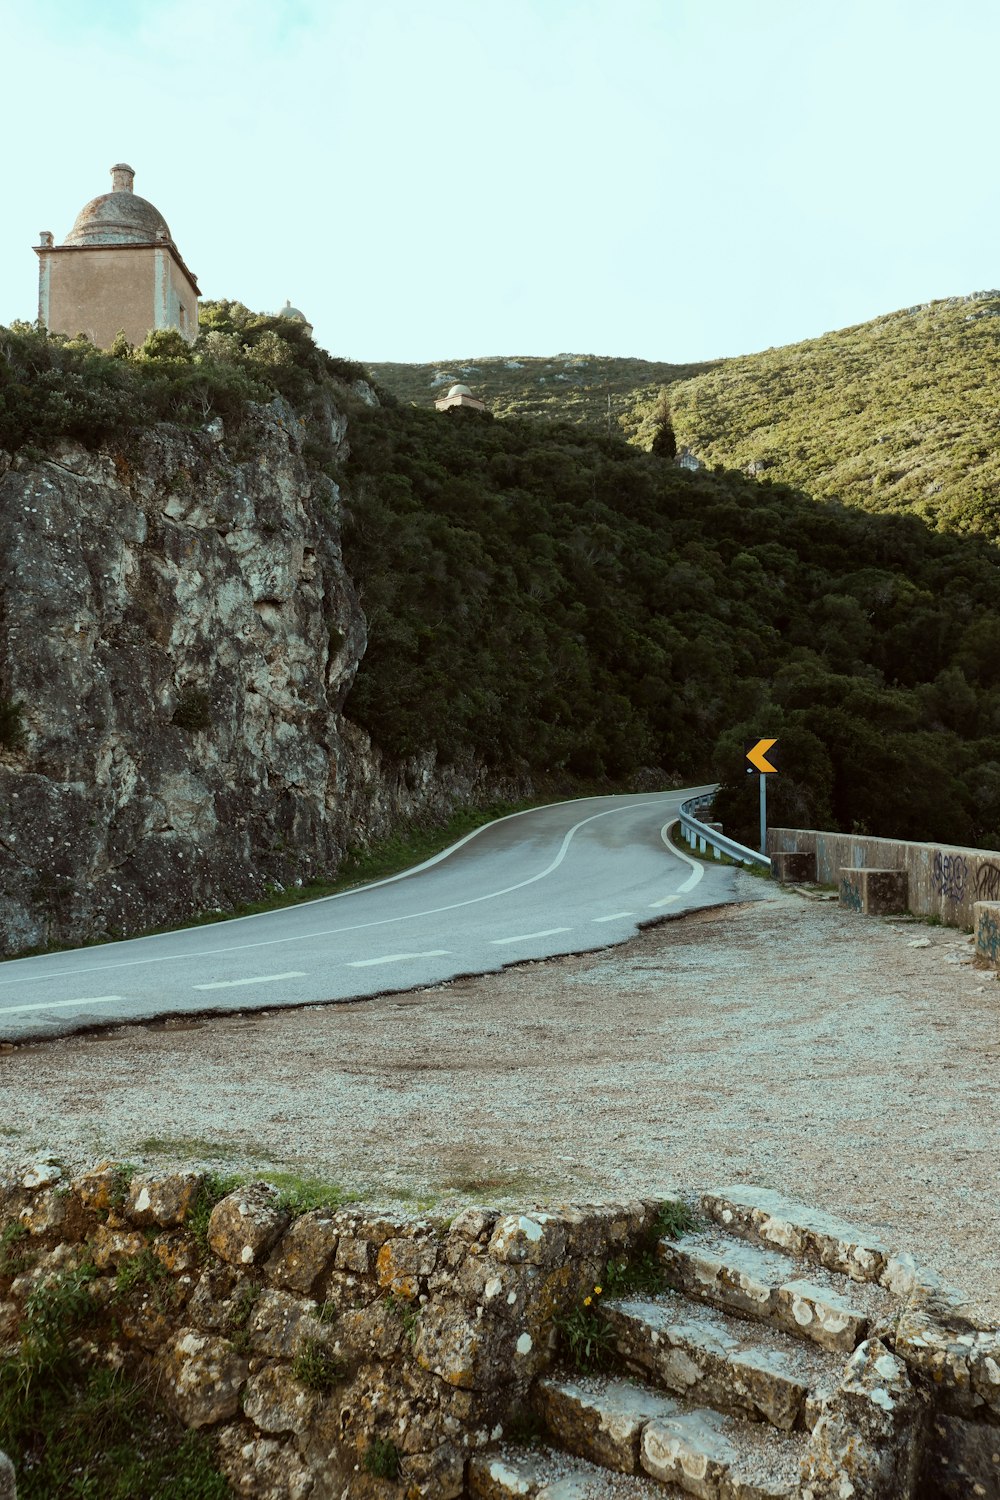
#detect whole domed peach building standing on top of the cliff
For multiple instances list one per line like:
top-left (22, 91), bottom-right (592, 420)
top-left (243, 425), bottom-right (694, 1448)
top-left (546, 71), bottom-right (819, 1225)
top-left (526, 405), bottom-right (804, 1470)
top-left (34, 162), bottom-right (199, 348)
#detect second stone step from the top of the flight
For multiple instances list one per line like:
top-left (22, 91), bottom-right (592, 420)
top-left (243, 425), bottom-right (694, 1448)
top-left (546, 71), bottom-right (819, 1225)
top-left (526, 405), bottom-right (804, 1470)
top-left (657, 1230), bottom-right (892, 1356)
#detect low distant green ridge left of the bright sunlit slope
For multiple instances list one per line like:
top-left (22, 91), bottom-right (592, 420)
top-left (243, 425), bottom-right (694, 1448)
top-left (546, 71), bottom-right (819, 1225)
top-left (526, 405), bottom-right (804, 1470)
top-left (369, 354), bottom-right (715, 432)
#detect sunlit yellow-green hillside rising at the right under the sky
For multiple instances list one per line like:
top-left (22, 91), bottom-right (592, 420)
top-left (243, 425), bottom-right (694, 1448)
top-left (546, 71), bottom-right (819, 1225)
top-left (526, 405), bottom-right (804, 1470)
top-left (670, 291), bottom-right (1000, 540)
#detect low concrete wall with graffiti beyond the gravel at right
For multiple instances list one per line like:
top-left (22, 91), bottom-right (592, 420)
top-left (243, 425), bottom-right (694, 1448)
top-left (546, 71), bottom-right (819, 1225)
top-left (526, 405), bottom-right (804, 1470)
top-left (768, 828), bottom-right (1000, 929)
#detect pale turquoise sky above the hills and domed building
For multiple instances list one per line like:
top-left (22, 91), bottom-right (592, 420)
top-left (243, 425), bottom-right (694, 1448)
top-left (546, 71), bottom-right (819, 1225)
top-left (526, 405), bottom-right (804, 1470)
top-left (0, 0), bottom-right (1000, 363)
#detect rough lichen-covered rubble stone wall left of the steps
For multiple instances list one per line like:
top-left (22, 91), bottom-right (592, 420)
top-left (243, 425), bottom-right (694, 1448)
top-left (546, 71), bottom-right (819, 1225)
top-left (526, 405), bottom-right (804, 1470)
top-left (0, 1164), bottom-right (657, 1500)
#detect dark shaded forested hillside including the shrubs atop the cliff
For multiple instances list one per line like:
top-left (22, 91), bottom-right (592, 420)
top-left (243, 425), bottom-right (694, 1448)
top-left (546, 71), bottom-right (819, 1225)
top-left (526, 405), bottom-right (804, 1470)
top-left (0, 305), bottom-right (1000, 848)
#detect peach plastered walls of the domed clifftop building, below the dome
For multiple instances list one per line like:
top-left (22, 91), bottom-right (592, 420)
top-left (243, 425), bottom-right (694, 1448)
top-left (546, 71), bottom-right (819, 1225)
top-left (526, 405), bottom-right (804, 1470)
top-left (39, 245), bottom-right (198, 348)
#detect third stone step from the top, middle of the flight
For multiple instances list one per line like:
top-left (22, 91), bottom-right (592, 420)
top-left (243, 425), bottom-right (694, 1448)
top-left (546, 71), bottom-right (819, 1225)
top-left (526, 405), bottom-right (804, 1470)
top-left (603, 1296), bottom-right (844, 1433)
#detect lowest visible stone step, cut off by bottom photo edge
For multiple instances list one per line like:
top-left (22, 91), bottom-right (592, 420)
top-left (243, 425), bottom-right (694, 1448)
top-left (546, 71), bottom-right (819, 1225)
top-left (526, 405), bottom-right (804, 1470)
top-left (468, 1443), bottom-right (680, 1500)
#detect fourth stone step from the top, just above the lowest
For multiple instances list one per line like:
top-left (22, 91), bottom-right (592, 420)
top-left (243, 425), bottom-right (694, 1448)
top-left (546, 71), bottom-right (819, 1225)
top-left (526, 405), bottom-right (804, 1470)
top-left (534, 1376), bottom-right (807, 1500)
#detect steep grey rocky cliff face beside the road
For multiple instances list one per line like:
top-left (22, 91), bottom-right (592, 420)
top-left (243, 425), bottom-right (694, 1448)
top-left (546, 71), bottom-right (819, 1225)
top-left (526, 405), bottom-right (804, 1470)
top-left (0, 401), bottom-right (515, 953)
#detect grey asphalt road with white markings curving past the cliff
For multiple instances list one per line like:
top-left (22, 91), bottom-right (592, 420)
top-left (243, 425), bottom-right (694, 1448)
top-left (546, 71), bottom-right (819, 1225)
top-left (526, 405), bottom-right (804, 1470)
top-left (0, 788), bottom-right (733, 1041)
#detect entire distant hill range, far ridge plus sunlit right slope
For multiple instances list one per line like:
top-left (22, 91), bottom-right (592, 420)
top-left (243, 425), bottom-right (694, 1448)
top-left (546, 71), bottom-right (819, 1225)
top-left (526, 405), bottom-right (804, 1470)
top-left (373, 291), bottom-right (1000, 552)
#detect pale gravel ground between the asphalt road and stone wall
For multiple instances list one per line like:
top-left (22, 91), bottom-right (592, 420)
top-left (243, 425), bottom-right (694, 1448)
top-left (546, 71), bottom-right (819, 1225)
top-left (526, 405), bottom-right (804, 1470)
top-left (0, 875), bottom-right (1000, 1319)
